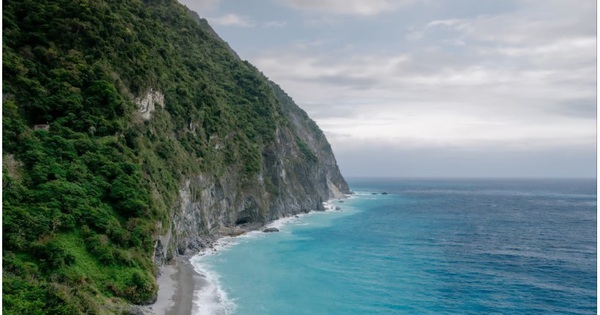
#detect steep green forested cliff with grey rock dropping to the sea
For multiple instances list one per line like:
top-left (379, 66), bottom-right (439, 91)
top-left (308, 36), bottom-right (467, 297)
top-left (2, 0), bottom-right (349, 314)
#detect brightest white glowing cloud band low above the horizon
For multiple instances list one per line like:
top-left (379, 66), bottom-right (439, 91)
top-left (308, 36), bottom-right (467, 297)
top-left (318, 110), bottom-right (595, 151)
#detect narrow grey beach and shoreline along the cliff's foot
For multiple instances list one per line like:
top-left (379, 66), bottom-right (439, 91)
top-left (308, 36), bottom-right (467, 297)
top-left (147, 195), bottom-right (351, 315)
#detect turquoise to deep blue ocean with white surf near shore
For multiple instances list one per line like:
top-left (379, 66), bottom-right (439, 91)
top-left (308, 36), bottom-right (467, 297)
top-left (192, 179), bottom-right (597, 315)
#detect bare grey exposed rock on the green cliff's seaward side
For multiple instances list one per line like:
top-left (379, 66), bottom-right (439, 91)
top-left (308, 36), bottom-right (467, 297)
top-left (152, 13), bottom-right (350, 264)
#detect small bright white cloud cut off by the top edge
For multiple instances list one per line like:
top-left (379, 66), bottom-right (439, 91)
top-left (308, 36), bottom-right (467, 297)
top-left (280, 0), bottom-right (410, 16)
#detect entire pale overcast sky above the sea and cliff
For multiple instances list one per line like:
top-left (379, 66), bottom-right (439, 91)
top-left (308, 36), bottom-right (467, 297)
top-left (180, 0), bottom-right (597, 177)
